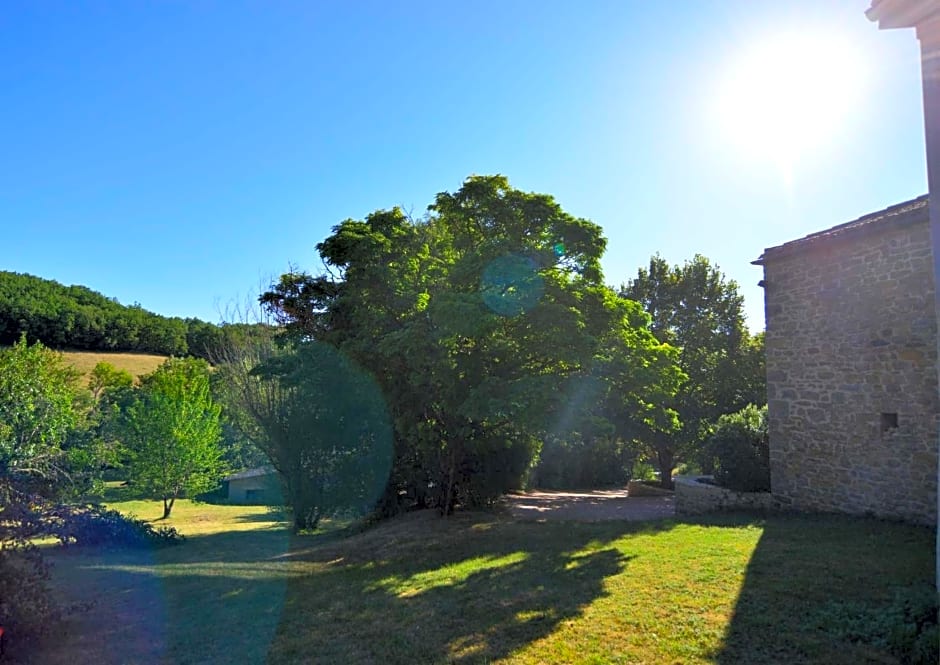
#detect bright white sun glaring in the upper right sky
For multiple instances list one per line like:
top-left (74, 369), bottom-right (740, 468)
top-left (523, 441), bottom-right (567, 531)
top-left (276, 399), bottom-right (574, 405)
top-left (716, 32), bottom-right (864, 172)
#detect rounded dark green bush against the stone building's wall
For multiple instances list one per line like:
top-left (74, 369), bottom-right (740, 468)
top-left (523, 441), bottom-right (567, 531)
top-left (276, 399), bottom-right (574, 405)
top-left (708, 404), bottom-right (770, 492)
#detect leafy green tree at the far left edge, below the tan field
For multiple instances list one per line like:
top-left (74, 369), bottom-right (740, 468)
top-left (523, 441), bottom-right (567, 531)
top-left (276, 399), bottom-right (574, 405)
top-left (0, 339), bottom-right (80, 479)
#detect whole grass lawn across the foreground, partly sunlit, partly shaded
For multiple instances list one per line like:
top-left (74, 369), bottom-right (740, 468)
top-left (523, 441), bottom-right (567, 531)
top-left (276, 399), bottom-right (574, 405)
top-left (25, 501), bottom-right (933, 665)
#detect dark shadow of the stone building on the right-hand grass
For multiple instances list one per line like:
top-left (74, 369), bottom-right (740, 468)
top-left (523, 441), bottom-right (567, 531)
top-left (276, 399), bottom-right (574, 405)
top-left (713, 515), bottom-right (934, 665)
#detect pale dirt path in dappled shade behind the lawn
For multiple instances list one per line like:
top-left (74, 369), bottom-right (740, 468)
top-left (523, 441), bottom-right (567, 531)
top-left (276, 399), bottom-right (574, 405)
top-left (505, 489), bottom-right (675, 522)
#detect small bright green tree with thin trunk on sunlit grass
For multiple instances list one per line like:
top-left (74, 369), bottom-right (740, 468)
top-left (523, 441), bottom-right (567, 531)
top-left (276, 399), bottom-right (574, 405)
top-left (124, 358), bottom-right (221, 519)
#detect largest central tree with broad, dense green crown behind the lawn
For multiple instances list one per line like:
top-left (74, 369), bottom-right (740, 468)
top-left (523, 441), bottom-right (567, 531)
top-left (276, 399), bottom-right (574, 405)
top-left (262, 176), bottom-right (679, 513)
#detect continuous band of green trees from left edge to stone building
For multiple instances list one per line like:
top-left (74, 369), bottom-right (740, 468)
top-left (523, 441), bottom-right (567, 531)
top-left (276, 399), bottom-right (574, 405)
top-left (0, 176), bottom-right (766, 529)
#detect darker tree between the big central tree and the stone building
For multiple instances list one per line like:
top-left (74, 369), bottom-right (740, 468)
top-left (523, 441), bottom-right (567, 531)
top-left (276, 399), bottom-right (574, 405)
top-left (621, 255), bottom-right (766, 485)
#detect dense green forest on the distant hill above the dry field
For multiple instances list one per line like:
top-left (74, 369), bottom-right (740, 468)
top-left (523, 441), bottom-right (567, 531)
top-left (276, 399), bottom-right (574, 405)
top-left (0, 271), bottom-right (241, 358)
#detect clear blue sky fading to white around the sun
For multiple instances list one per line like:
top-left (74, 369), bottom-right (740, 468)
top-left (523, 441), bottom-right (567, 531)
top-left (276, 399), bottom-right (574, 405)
top-left (0, 0), bottom-right (927, 330)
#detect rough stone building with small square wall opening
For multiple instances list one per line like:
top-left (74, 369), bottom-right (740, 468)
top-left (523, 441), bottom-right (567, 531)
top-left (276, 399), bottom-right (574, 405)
top-left (754, 196), bottom-right (938, 525)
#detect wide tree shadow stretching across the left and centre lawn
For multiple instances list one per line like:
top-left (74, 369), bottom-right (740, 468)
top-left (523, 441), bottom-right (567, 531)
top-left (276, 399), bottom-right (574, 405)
top-left (36, 515), bottom-right (671, 665)
